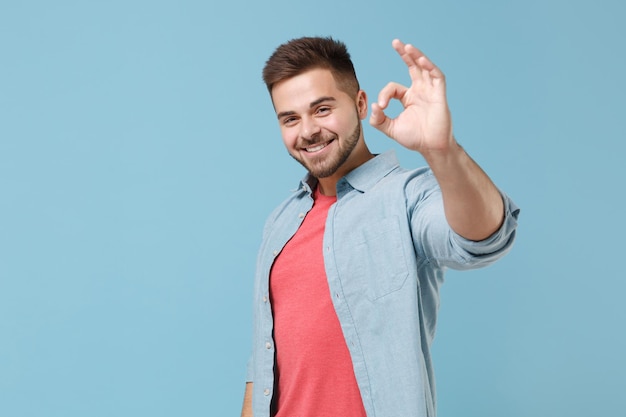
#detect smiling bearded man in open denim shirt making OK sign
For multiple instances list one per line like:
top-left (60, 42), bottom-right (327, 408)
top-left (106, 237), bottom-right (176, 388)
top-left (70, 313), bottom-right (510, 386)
top-left (242, 38), bottom-right (519, 417)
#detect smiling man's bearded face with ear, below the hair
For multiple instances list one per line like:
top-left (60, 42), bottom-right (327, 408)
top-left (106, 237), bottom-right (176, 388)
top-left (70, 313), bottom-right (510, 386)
top-left (272, 69), bottom-right (367, 178)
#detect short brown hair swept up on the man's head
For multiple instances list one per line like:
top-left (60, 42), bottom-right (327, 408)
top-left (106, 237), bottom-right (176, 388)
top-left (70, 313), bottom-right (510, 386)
top-left (263, 37), bottom-right (360, 96)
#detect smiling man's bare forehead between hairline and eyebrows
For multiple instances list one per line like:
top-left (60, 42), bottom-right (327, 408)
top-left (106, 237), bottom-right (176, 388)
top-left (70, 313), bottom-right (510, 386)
top-left (272, 68), bottom-right (348, 112)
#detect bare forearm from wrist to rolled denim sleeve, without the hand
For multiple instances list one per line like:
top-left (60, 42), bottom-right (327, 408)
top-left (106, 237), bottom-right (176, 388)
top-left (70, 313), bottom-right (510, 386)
top-left (422, 142), bottom-right (504, 241)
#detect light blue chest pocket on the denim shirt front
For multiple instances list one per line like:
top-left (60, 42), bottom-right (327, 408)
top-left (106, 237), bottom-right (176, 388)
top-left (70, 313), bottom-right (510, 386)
top-left (336, 217), bottom-right (409, 301)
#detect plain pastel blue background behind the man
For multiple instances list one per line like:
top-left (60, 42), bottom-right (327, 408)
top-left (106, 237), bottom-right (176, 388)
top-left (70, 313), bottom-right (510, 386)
top-left (0, 0), bottom-right (626, 417)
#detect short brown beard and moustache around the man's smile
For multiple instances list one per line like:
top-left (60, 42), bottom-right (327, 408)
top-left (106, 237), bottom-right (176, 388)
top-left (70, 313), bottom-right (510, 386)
top-left (290, 119), bottom-right (361, 178)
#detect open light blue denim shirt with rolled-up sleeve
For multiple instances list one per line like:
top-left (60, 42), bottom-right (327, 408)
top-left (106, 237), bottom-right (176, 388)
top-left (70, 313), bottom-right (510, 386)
top-left (247, 151), bottom-right (519, 417)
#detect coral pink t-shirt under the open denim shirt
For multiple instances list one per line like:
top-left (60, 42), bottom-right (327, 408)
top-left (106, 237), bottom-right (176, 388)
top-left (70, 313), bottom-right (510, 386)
top-left (270, 190), bottom-right (365, 417)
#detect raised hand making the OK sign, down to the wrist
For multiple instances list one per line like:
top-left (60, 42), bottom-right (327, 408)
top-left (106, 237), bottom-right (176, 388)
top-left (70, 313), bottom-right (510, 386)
top-left (370, 39), bottom-right (455, 156)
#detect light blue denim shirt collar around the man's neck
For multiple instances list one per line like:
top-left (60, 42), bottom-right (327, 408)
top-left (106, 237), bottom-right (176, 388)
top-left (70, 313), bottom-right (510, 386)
top-left (298, 149), bottom-right (400, 196)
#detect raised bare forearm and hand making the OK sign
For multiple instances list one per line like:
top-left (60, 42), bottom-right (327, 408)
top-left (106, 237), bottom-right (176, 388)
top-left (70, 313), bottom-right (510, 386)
top-left (370, 39), bottom-right (504, 241)
